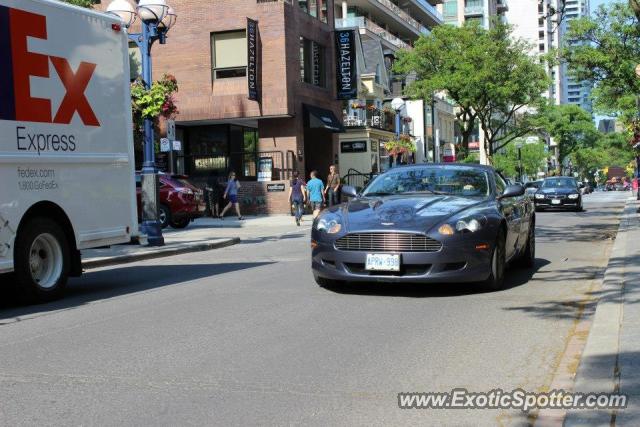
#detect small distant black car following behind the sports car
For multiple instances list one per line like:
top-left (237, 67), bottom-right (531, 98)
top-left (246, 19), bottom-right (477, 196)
top-left (533, 176), bottom-right (583, 212)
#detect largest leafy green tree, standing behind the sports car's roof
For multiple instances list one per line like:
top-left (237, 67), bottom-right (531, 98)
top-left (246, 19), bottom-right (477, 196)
top-left (394, 23), bottom-right (549, 160)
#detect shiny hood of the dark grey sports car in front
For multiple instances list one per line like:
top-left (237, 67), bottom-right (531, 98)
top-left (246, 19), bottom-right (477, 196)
top-left (341, 195), bottom-right (486, 232)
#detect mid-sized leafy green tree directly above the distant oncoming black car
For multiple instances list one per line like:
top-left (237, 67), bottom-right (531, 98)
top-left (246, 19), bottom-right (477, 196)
top-left (534, 104), bottom-right (599, 162)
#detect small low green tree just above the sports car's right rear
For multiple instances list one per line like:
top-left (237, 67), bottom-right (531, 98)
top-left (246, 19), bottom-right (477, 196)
top-left (493, 141), bottom-right (547, 178)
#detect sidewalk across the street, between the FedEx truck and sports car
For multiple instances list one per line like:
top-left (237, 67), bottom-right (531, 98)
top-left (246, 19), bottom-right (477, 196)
top-left (82, 215), bottom-right (312, 269)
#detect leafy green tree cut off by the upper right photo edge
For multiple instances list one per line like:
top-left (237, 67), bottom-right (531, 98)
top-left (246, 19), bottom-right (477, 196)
top-left (561, 3), bottom-right (640, 122)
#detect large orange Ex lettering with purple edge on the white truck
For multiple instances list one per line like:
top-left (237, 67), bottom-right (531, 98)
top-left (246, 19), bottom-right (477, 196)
top-left (0, 6), bottom-right (100, 126)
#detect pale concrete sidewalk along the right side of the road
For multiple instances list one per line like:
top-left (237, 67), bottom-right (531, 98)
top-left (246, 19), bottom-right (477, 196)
top-left (564, 198), bottom-right (640, 426)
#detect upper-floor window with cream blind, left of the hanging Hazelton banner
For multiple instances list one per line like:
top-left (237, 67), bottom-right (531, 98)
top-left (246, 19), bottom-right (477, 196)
top-left (211, 30), bottom-right (247, 80)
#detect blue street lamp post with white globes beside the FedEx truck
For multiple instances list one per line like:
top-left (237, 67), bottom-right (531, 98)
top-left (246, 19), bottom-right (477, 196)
top-left (107, 0), bottom-right (177, 246)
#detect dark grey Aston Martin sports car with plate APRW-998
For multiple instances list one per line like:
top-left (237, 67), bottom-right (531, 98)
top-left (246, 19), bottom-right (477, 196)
top-left (311, 163), bottom-right (535, 290)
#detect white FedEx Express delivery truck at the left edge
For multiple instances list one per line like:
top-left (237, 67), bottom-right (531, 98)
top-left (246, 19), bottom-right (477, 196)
top-left (0, 0), bottom-right (138, 302)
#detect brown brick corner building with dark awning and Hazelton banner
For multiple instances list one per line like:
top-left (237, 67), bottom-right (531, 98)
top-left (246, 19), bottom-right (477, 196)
top-left (127, 0), bottom-right (342, 213)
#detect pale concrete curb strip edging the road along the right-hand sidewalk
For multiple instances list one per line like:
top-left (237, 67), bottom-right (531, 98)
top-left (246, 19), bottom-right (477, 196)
top-left (564, 200), bottom-right (636, 426)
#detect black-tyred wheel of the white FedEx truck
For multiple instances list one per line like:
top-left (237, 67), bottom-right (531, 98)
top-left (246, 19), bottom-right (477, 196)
top-left (15, 218), bottom-right (71, 303)
